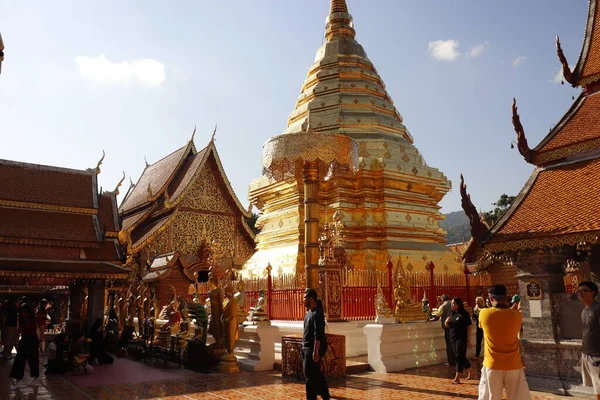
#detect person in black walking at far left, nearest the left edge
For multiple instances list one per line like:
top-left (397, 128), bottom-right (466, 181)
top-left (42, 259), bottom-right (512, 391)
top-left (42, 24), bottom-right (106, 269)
top-left (10, 302), bottom-right (40, 390)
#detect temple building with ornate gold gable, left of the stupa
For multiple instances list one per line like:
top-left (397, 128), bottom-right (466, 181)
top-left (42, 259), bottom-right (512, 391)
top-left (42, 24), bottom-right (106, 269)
top-left (119, 137), bottom-right (254, 306)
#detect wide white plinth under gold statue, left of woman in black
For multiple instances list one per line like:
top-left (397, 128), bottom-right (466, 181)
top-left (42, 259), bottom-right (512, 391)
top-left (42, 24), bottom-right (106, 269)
top-left (363, 322), bottom-right (446, 372)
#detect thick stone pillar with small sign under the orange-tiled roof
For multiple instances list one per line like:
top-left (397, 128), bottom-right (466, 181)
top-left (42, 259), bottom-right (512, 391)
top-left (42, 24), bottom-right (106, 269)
top-left (513, 247), bottom-right (583, 394)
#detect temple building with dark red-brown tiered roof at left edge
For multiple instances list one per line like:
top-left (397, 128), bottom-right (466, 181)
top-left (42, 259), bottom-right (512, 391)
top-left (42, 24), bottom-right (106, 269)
top-left (0, 155), bottom-right (129, 322)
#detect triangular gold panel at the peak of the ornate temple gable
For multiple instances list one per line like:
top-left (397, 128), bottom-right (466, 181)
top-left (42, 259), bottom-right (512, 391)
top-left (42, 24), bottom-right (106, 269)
top-left (179, 165), bottom-right (233, 212)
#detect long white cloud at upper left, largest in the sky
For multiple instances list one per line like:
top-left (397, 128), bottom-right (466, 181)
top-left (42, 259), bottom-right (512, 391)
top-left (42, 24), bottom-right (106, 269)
top-left (75, 54), bottom-right (167, 87)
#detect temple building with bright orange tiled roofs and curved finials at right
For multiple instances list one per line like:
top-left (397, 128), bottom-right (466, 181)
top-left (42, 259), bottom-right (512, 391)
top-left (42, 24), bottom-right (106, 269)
top-left (461, 0), bottom-right (600, 393)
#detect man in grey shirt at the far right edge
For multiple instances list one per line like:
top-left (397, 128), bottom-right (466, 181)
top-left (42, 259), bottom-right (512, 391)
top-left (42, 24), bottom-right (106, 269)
top-left (577, 281), bottom-right (600, 400)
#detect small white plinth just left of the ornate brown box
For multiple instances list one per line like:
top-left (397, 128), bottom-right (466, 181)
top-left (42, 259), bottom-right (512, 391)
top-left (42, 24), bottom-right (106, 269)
top-left (234, 325), bottom-right (279, 372)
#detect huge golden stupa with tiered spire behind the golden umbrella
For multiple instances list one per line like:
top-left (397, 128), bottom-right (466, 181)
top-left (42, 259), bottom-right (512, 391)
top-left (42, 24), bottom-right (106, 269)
top-left (244, 0), bottom-right (462, 277)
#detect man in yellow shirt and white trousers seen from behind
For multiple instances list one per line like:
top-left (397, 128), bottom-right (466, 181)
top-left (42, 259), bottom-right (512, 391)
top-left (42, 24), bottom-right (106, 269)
top-left (479, 285), bottom-right (531, 400)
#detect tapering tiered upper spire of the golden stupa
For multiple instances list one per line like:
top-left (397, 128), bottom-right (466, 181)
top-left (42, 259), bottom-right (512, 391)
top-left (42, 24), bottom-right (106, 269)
top-left (285, 0), bottom-right (413, 143)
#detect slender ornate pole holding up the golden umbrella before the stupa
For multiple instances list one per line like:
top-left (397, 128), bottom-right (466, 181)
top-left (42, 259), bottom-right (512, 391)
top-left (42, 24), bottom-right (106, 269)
top-left (302, 161), bottom-right (323, 295)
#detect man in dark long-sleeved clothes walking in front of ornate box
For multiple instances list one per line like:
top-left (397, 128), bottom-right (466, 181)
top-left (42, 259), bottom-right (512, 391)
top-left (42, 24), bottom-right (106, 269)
top-left (302, 288), bottom-right (331, 400)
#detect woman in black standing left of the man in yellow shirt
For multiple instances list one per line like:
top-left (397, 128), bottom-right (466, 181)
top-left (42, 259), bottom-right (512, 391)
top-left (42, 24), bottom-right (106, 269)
top-left (444, 297), bottom-right (472, 385)
